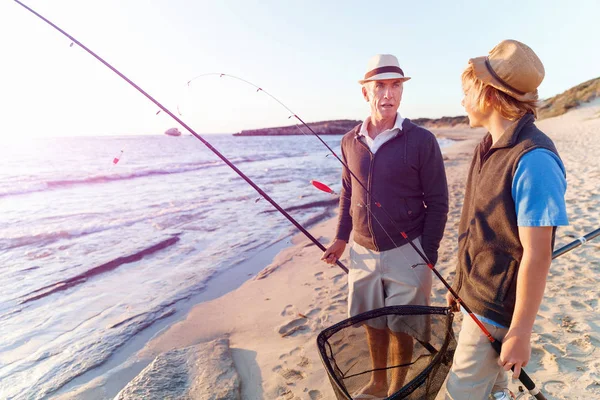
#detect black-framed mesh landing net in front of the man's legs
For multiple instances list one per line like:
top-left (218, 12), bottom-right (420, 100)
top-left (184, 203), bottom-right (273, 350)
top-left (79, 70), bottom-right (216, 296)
top-left (317, 306), bottom-right (456, 400)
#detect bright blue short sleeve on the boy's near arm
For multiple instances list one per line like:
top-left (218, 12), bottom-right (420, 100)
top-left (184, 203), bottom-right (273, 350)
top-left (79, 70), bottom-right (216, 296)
top-left (512, 149), bottom-right (569, 226)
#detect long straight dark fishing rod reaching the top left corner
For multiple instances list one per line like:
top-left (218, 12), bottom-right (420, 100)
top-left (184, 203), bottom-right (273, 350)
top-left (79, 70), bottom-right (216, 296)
top-left (14, 0), bottom-right (348, 273)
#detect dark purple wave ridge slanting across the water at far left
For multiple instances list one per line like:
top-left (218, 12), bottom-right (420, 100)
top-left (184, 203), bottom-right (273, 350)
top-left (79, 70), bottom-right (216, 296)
top-left (20, 236), bottom-right (179, 304)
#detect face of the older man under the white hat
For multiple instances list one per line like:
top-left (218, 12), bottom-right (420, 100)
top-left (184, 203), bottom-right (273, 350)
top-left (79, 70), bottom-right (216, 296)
top-left (362, 79), bottom-right (404, 119)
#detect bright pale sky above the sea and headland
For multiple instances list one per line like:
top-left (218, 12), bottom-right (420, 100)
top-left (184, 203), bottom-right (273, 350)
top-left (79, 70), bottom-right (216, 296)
top-left (0, 0), bottom-right (600, 139)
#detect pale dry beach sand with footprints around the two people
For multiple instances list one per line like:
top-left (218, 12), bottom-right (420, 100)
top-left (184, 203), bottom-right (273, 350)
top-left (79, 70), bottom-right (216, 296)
top-left (96, 104), bottom-right (600, 400)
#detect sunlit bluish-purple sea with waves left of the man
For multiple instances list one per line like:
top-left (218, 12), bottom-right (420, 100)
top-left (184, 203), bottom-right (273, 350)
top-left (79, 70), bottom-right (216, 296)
top-left (0, 135), bottom-right (450, 399)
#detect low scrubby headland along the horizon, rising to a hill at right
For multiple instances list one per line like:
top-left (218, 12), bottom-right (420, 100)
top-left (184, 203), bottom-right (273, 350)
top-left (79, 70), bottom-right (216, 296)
top-left (233, 77), bottom-right (600, 136)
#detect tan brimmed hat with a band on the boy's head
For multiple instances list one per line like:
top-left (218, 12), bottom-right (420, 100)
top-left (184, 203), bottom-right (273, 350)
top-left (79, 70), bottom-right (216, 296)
top-left (469, 40), bottom-right (545, 101)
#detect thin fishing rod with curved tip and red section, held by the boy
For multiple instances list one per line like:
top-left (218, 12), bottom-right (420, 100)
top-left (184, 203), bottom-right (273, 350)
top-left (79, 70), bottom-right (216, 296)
top-left (185, 75), bottom-right (546, 400)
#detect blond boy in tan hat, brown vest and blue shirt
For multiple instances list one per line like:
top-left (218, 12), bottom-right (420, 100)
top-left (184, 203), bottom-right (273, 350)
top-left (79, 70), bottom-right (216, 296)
top-left (445, 40), bottom-right (568, 400)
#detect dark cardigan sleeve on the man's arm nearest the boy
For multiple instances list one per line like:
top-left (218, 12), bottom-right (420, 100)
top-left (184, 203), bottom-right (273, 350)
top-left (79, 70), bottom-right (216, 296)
top-left (419, 133), bottom-right (448, 264)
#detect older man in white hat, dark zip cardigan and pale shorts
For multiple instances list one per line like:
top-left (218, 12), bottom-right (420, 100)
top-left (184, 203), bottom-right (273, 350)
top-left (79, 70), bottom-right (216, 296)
top-left (322, 54), bottom-right (448, 399)
